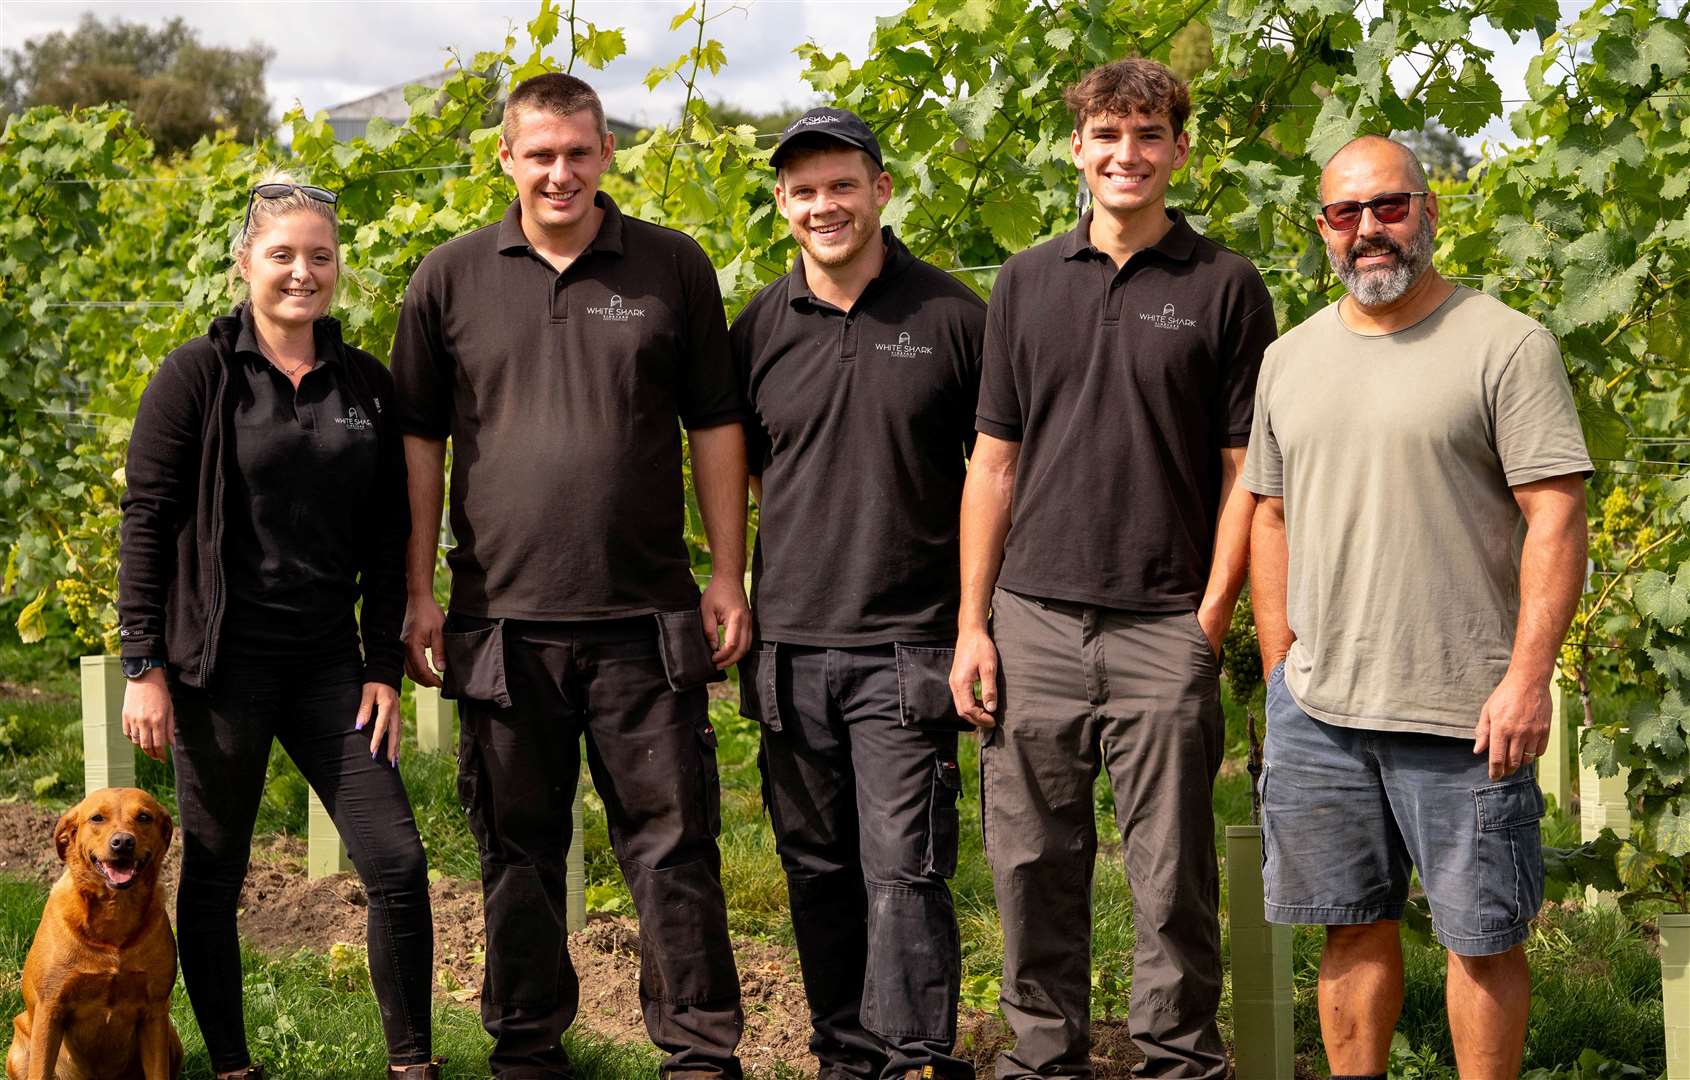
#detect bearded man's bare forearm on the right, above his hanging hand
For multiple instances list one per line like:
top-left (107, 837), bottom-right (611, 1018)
top-left (1507, 480), bottom-right (1589, 683)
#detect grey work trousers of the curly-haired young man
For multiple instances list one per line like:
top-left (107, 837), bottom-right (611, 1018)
top-left (980, 588), bottom-right (1227, 1080)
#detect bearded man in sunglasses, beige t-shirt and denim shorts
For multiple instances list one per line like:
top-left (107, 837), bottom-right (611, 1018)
top-left (1244, 135), bottom-right (1590, 1080)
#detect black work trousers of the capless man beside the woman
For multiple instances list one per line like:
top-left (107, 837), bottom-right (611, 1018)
top-left (444, 612), bottom-right (744, 1080)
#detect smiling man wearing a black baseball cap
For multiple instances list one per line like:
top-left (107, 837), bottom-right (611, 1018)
top-left (728, 108), bottom-right (985, 1078)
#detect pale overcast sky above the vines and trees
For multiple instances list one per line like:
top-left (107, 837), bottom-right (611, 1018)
top-left (0, 0), bottom-right (1589, 152)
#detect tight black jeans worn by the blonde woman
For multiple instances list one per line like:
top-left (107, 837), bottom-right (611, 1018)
top-left (171, 656), bottom-right (434, 1072)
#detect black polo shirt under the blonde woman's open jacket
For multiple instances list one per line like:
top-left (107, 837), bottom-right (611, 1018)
top-left (218, 304), bottom-right (380, 659)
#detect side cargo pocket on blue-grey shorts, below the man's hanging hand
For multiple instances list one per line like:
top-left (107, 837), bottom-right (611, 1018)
top-left (1474, 769), bottom-right (1543, 933)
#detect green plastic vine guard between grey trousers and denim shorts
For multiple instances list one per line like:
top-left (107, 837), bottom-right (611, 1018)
top-left (1227, 825), bottom-right (1295, 1080)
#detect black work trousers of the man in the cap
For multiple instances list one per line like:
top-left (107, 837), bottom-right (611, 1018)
top-left (740, 642), bottom-right (973, 1080)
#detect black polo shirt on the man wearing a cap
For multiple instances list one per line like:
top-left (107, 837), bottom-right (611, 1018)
top-left (730, 228), bottom-right (985, 646)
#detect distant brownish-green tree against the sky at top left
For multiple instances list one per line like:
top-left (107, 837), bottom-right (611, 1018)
top-left (0, 15), bottom-right (275, 154)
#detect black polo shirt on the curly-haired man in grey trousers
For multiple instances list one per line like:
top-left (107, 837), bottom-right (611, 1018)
top-left (975, 211), bottom-right (1276, 612)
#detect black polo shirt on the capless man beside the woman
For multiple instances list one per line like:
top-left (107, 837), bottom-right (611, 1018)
top-left (392, 193), bottom-right (744, 620)
